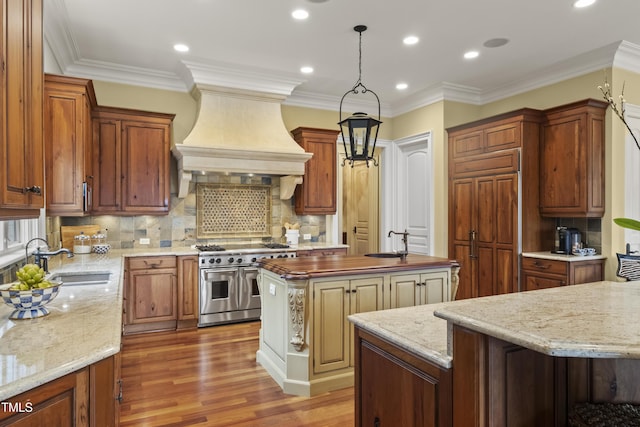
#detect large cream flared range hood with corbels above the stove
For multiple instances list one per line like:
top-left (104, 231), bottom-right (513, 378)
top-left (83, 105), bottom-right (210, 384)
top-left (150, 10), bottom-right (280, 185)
top-left (171, 65), bottom-right (312, 199)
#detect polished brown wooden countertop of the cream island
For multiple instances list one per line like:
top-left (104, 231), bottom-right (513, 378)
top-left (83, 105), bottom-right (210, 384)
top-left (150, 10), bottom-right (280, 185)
top-left (258, 254), bottom-right (458, 280)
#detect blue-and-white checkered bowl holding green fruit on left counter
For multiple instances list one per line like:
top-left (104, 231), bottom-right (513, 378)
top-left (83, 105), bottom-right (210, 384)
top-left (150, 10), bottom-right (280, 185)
top-left (0, 283), bottom-right (62, 319)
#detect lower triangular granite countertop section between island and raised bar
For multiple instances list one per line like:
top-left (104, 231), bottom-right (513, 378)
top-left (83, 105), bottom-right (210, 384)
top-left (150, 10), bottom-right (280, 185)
top-left (349, 303), bottom-right (452, 369)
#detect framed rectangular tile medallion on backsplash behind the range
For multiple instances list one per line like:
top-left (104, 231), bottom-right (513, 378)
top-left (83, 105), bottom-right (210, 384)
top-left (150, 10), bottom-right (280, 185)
top-left (196, 184), bottom-right (271, 239)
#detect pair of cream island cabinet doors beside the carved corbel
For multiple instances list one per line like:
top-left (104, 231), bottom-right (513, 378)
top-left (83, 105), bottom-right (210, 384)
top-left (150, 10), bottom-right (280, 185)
top-left (313, 276), bottom-right (384, 374)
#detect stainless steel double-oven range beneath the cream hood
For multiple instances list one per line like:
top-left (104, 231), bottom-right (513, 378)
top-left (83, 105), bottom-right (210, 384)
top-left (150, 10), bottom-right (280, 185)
top-left (196, 243), bottom-right (296, 326)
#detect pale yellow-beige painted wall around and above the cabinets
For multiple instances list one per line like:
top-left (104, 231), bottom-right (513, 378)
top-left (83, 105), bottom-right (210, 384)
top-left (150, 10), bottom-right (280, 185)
top-left (94, 69), bottom-right (640, 278)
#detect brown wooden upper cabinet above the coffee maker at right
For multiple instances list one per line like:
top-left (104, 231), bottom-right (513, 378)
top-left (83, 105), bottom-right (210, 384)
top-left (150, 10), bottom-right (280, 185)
top-left (540, 99), bottom-right (607, 217)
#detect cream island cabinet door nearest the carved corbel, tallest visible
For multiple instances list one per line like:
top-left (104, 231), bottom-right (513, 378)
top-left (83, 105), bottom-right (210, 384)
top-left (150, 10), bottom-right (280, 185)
top-left (313, 280), bottom-right (351, 373)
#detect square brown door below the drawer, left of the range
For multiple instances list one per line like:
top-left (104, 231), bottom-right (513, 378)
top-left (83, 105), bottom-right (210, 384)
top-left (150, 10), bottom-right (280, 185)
top-left (129, 269), bottom-right (178, 323)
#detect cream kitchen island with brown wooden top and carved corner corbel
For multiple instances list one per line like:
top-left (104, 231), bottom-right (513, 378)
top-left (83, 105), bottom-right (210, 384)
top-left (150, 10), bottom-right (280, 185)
top-left (256, 254), bottom-right (459, 396)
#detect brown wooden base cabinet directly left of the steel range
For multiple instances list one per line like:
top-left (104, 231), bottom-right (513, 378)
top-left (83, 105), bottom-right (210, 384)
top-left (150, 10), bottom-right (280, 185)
top-left (123, 255), bottom-right (198, 334)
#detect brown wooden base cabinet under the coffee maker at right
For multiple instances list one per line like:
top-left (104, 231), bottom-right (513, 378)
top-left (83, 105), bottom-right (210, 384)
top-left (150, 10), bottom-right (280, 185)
top-left (521, 257), bottom-right (604, 291)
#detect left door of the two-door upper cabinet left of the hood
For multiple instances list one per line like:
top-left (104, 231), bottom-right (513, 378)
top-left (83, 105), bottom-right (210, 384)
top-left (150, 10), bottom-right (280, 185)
top-left (93, 119), bottom-right (124, 213)
